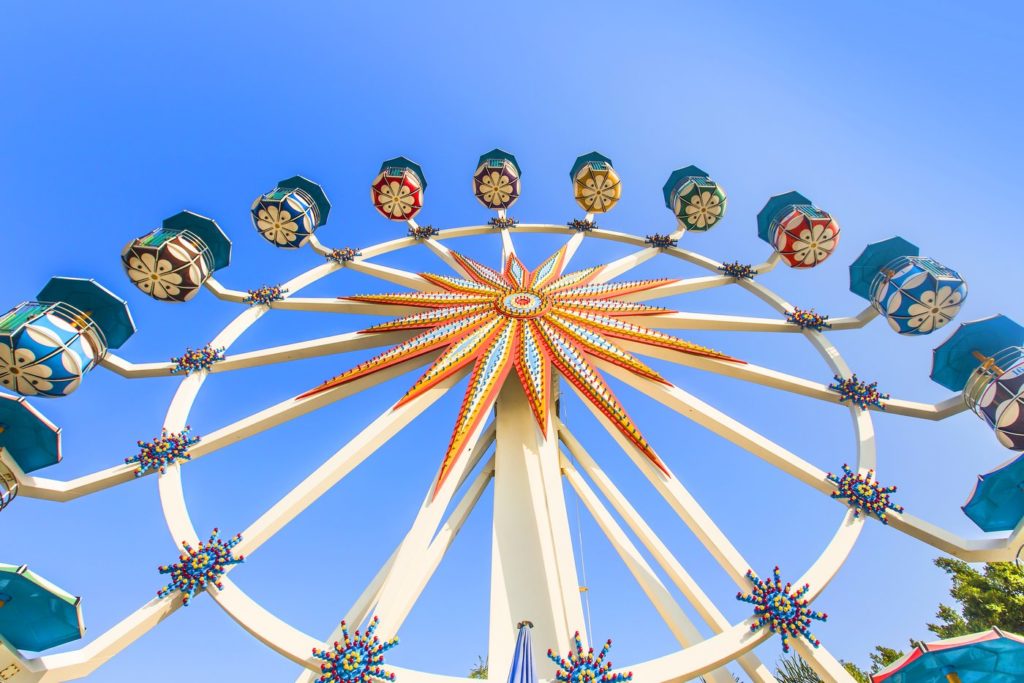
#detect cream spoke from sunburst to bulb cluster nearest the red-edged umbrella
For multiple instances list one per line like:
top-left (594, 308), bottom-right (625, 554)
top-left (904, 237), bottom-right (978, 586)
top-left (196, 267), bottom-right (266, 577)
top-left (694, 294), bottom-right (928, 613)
top-left (573, 374), bottom-right (751, 588)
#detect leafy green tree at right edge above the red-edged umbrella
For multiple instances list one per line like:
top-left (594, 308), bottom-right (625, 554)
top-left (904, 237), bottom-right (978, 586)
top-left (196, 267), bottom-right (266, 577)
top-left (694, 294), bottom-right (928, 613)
top-left (928, 557), bottom-right (1024, 638)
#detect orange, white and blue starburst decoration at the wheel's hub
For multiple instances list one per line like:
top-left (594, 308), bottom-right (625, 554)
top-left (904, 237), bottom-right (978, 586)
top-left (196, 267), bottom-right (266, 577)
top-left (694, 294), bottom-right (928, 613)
top-left (299, 247), bottom-right (741, 493)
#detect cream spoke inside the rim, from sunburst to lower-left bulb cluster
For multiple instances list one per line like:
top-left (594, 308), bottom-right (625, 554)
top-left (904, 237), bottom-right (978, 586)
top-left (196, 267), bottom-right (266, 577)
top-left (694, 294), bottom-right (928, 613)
top-left (238, 366), bottom-right (462, 555)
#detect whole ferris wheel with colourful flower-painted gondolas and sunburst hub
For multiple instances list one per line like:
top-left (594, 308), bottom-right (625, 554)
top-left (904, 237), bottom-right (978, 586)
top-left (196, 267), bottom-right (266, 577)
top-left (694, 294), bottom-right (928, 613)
top-left (0, 150), bottom-right (1024, 683)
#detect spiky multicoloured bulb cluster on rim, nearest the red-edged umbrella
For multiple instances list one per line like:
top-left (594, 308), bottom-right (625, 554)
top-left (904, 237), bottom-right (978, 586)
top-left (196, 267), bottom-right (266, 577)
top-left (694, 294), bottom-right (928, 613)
top-left (736, 567), bottom-right (828, 652)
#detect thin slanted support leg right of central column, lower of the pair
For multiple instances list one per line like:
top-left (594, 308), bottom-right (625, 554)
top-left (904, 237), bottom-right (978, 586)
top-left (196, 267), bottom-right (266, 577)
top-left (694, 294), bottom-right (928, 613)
top-left (560, 457), bottom-right (732, 683)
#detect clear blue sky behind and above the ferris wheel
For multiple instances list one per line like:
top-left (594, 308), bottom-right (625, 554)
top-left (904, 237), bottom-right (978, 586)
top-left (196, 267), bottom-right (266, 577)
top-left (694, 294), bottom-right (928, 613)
top-left (0, 0), bottom-right (1024, 683)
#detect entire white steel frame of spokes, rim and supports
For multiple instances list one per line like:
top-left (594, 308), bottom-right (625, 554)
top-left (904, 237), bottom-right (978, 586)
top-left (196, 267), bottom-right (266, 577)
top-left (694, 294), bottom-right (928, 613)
top-left (0, 220), bottom-right (1024, 683)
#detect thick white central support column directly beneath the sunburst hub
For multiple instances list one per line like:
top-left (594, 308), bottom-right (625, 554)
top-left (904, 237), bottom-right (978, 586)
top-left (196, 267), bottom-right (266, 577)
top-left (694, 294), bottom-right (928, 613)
top-left (488, 377), bottom-right (586, 681)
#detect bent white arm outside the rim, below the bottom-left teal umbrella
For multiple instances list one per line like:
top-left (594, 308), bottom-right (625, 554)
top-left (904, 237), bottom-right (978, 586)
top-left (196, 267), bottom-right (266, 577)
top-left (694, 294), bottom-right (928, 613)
top-left (24, 594), bottom-right (182, 681)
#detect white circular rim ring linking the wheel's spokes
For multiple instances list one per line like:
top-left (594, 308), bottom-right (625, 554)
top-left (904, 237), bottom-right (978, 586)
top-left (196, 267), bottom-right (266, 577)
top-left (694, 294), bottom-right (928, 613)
top-left (158, 223), bottom-right (876, 683)
